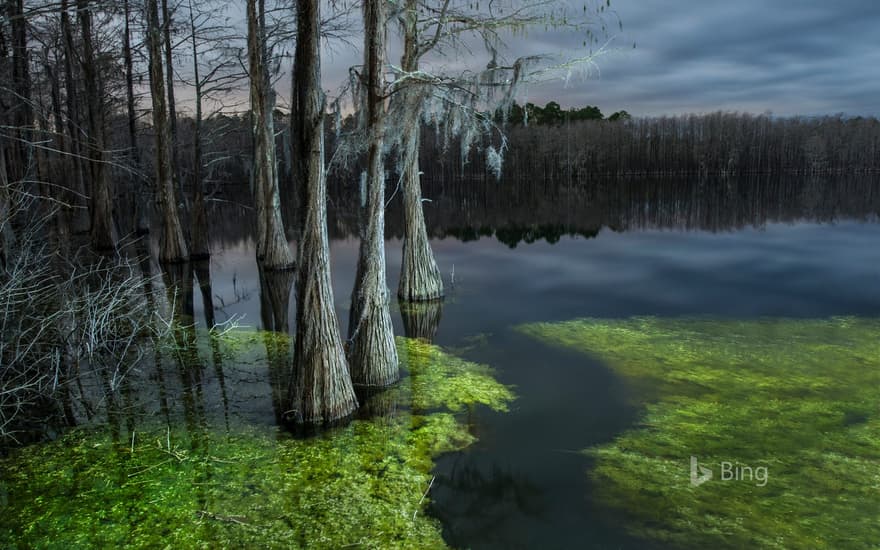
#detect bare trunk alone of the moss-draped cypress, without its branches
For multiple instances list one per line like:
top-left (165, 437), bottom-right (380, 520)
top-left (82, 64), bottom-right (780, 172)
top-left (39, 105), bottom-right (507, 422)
top-left (397, 0), bottom-right (443, 301)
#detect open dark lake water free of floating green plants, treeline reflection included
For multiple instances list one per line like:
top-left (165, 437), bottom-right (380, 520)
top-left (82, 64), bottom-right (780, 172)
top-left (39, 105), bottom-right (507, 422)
top-left (196, 178), bottom-right (880, 548)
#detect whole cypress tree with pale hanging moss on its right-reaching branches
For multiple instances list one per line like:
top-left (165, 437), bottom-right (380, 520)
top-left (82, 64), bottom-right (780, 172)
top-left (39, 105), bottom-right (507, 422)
top-left (393, 0), bottom-right (605, 301)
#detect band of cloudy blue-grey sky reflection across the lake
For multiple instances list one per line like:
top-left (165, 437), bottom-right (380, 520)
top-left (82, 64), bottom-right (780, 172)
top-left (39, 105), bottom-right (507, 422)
top-left (196, 222), bottom-right (880, 343)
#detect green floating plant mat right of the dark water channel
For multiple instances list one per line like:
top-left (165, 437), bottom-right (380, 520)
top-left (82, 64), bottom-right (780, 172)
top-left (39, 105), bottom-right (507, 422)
top-left (519, 318), bottom-right (880, 549)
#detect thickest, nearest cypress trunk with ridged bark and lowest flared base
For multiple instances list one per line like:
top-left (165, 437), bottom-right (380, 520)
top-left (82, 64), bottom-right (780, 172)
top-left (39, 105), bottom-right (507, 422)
top-left (288, 0), bottom-right (357, 423)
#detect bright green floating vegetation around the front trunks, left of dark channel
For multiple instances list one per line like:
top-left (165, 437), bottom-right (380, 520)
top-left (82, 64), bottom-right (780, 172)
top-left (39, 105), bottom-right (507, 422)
top-left (0, 336), bottom-right (513, 548)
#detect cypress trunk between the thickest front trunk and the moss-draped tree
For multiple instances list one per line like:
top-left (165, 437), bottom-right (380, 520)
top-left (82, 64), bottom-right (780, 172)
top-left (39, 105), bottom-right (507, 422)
top-left (349, 0), bottom-right (400, 387)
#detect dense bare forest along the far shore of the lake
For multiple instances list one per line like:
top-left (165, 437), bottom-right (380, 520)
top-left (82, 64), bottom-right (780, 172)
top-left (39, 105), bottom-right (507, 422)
top-left (101, 108), bottom-right (880, 198)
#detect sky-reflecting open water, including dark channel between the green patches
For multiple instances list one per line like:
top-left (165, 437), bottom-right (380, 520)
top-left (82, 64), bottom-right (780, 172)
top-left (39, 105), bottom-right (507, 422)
top-left (174, 189), bottom-right (880, 548)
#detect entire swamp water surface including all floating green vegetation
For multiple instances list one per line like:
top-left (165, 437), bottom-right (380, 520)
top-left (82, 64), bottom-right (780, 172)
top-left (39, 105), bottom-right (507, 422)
top-left (0, 179), bottom-right (880, 548)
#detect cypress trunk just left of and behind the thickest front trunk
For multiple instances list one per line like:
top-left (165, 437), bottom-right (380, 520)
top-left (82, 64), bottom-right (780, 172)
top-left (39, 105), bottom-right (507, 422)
top-left (247, 0), bottom-right (293, 269)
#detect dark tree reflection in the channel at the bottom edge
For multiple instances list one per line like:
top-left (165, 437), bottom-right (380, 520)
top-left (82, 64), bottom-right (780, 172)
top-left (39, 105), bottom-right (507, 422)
top-left (429, 456), bottom-right (546, 547)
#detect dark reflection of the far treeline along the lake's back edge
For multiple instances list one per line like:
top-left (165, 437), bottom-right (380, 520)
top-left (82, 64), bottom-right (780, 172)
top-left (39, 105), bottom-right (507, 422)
top-left (205, 175), bottom-right (880, 247)
